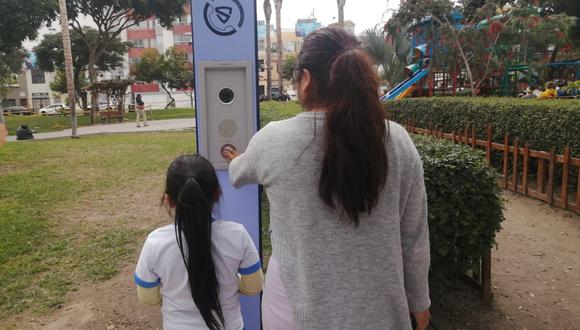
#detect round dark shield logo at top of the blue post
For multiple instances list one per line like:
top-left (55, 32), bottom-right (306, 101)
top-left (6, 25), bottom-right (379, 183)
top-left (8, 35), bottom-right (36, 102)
top-left (203, 0), bottom-right (244, 37)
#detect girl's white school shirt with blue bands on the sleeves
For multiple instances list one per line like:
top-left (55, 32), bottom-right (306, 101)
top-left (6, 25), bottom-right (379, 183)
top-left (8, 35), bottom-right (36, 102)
top-left (135, 221), bottom-right (261, 330)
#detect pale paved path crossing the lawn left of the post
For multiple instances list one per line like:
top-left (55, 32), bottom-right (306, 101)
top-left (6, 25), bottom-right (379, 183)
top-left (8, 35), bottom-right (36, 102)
top-left (7, 118), bottom-right (195, 142)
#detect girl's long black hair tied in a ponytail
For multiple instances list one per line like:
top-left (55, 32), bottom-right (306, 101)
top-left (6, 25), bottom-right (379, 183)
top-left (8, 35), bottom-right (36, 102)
top-left (165, 155), bottom-right (224, 330)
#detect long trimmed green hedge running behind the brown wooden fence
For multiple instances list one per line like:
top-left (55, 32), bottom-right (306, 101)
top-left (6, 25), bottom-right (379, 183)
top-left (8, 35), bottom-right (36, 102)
top-left (385, 97), bottom-right (580, 156)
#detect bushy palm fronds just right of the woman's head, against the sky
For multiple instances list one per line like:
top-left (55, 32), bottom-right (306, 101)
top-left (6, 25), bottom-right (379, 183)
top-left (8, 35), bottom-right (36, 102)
top-left (360, 27), bottom-right (405, 87)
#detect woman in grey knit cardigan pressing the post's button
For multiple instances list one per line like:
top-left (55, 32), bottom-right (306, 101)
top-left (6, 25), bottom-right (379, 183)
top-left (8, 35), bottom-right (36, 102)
top-left (226, 28), bottom-right (430, 330)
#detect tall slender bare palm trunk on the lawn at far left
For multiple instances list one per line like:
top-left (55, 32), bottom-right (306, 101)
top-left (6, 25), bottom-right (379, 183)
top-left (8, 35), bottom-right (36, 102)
top-left (58, 0), bottom-right (78, 138)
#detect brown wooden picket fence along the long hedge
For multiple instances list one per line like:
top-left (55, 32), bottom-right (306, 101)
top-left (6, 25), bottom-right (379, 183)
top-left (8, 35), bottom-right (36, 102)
top-left (404, 120), bottom-right (580, 214)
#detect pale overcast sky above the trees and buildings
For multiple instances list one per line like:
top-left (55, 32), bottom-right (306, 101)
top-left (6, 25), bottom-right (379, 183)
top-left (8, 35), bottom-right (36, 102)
top-left (24, 0), bottom-right (400, 50)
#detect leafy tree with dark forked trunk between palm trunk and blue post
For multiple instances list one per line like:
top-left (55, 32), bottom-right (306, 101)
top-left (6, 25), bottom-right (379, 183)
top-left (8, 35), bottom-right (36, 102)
top-left (67, 0), bottom-right (188, 122)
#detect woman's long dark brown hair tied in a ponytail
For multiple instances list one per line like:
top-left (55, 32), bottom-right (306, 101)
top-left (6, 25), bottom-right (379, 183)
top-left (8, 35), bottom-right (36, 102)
top-left (298, 28), bottom-right (388, 225)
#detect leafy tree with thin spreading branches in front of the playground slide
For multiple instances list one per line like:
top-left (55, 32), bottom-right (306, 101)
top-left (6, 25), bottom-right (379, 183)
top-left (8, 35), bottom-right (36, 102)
top-left (386, 0), bottom-right (570, 96)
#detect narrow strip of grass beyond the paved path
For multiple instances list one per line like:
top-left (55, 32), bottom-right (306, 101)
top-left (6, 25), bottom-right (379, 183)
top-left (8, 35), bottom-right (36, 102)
top-left (5, 108), bottom-right (195, 135)
